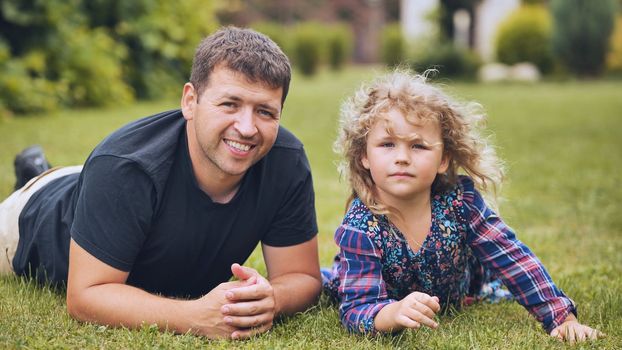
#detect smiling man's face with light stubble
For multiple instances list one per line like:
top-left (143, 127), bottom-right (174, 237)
top-left (182, 66), bottom-right (282, 179)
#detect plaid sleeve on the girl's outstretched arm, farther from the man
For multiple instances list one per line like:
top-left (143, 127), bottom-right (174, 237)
top-left (462, 179), bottom-right (576, 332)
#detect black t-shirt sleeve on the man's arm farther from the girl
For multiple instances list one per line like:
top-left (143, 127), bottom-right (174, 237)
top-left (71, 156), bottom-right (155, 271)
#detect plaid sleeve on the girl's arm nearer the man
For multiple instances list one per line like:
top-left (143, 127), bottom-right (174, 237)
top-left (335, 225), bottom-right (395, 334)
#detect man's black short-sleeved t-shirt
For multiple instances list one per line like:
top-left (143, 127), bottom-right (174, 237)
top-left (13, 111), bottom-right (317, 297)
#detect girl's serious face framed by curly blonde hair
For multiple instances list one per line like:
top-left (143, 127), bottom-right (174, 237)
top-left (361, 109), bottom-right (449, 204)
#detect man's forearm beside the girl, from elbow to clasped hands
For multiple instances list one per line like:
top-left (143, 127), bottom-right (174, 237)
top-left (270, 273), bottom-right (322, 315)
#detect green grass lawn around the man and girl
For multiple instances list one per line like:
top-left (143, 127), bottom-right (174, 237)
top-left (0, 68), bottom-right (622, 349)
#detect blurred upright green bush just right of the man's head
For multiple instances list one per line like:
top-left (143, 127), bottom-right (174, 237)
top-left (292, 22), bottom-right (322, 76)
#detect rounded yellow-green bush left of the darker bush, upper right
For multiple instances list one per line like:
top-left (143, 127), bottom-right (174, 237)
top-left (496, 5), bottom-right (553, 74)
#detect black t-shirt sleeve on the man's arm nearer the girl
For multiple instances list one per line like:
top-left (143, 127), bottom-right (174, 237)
top-left (262, 150), bottom-right (318, 247)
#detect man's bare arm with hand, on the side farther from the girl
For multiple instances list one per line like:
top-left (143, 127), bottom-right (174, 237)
top-left (67, 240), bottom-right (249, 338)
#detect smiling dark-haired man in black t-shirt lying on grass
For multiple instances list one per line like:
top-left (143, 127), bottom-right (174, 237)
top-left (0, 28), bottom-right (321, 339)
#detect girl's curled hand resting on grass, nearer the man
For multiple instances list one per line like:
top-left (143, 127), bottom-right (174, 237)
top-left (374, 292), bottom-right (441, 332)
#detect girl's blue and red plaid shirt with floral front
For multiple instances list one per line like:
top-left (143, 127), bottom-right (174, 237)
top-left (330, 176), bottom-right (576, 333)
